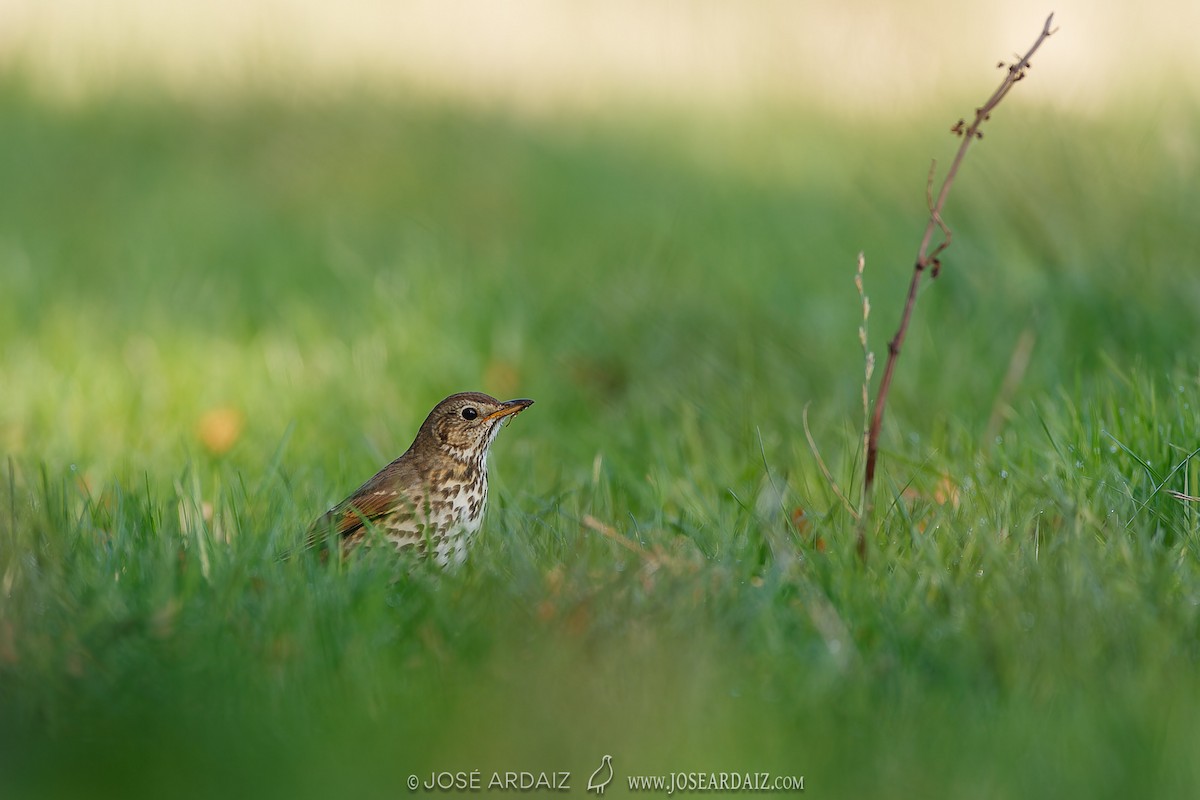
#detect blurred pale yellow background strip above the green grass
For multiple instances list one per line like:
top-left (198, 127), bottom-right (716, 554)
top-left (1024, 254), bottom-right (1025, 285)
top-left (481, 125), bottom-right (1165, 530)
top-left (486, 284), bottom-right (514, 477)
top-left (0, 0), bottom-right (1200, 114)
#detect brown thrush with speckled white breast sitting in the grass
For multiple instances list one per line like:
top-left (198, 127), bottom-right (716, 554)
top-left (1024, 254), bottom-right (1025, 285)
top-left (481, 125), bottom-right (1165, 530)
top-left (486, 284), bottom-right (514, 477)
top-left (306, 392), bottom-right (533, 569)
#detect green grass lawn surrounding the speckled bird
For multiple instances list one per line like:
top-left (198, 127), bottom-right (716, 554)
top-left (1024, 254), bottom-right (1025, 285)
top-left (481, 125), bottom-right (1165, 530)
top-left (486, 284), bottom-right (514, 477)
top-left (0, 84), bottom-right (1200, 798)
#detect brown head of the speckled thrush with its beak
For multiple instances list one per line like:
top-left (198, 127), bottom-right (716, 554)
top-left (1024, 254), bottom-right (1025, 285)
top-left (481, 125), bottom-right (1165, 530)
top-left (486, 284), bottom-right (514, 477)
top-left (413, 392), bottom-right (533, 463)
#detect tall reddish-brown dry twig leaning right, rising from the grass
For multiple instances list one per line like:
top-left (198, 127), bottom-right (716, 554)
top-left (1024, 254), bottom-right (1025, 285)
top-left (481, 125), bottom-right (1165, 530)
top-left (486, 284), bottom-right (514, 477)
top-left (859, 14), bottom-right (1056, 558)
